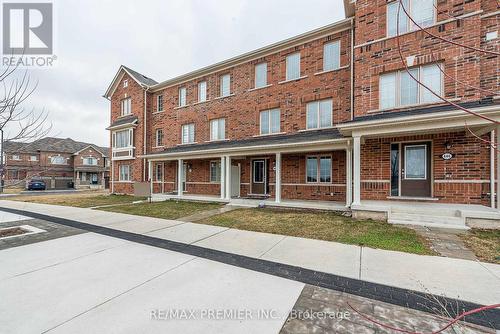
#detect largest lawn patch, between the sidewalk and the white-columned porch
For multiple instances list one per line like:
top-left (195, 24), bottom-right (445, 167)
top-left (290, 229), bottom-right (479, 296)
top-left (197, 208), bottom-right (435, 255)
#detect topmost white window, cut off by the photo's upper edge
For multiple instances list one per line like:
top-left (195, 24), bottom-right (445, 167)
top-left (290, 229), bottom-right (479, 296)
top-left (387, 0), bottom-right (436, 37)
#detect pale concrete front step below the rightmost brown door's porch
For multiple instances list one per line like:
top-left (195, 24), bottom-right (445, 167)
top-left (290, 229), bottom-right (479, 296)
top-left (388, 212), bottom-right (467, 229)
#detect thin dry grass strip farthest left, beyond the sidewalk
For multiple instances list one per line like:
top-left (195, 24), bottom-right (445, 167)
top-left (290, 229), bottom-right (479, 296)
top-left (5, 193), bottom-right (146, 208)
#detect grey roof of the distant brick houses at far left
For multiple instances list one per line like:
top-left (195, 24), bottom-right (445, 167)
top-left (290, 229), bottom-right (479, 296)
top-left (4, 137), bottom-right (109, 157)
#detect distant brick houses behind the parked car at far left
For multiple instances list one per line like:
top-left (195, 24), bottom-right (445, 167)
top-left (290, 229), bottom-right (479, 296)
top-left (4, 137), bottom-right (110, 189)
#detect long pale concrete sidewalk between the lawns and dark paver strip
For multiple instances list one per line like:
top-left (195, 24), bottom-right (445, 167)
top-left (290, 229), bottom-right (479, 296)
top-left (0, 201), bottom-right (500, 305)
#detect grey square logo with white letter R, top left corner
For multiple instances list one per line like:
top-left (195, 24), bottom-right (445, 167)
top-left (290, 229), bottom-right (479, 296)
top-left (3, 3), bottom-right (53, 55)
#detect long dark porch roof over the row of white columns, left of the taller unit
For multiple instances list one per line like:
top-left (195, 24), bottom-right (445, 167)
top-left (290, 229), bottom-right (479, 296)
top-left (142, 128), bottom-right (348, 158)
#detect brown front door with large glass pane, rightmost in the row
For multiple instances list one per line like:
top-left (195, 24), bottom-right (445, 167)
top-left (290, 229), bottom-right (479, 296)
top-left (401, 143), bottom-right (431, 197)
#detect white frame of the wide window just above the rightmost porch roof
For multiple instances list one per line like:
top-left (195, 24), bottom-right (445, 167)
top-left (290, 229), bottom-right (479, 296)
top-left (378, 63), bottom-right (444, 110)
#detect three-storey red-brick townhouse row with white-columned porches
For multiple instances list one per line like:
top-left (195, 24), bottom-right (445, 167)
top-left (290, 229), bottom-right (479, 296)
top-left (105, 0), bottom-right (500, 227)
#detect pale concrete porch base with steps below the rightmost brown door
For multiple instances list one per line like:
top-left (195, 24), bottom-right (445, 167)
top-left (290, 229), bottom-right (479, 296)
top-left (351, 200), bottom-right (500, 229)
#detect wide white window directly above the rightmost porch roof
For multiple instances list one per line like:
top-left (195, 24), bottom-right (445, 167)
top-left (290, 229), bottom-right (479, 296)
top-left (379, 64), bottom-right (443, 109)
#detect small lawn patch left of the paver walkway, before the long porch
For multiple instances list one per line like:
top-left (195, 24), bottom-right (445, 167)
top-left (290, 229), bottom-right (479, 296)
top-left (99, 200), bottom-right (223, 219)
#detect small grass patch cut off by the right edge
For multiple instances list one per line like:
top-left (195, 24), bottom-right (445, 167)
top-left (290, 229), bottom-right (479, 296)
top-left (460, 229), bottom-right (500, 264)
